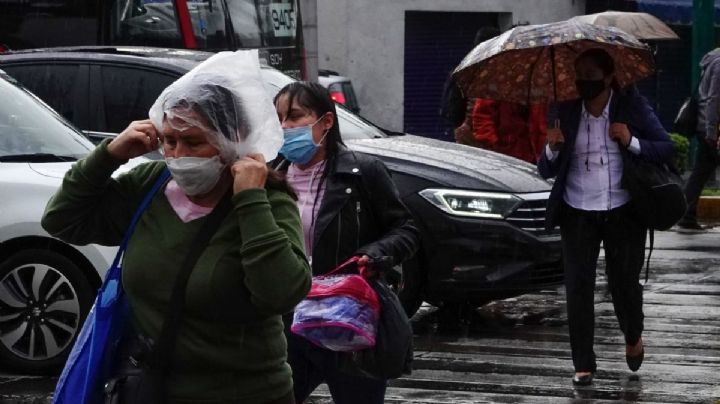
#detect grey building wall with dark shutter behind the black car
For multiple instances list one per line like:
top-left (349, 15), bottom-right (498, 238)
top-left (317, 0), bottom-right (585, 140)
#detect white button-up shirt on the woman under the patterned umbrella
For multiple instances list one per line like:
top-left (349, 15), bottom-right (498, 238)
top-left (545, 93), bottom-right (640, 211)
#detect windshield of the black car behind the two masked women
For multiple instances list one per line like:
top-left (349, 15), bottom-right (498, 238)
top-left (263, 68), bottom-right (387, 140)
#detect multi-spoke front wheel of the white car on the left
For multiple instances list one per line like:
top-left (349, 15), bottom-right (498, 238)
top-left (0, 250), bottom-right (93, 373)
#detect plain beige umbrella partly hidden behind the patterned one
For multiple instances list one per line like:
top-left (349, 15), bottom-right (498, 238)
top-left (572, 11), bottom-right (680, 41)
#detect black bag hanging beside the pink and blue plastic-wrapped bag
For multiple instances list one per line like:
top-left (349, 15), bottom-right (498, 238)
top-left (339, 279), bottom-right (413, 380)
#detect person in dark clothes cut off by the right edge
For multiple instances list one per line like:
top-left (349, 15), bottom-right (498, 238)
top-left (677, 48), bottom-right (720, 232)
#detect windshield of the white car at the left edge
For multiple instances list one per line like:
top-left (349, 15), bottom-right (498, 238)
top-left (0, 75), bottom-right (92, 162)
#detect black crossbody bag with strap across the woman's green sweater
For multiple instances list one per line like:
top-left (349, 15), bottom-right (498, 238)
top-left (105, 195), bottom-right (232, 404)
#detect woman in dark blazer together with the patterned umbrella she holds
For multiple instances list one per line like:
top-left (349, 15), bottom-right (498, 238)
top-left (453, 19), bottom-right (673, 385)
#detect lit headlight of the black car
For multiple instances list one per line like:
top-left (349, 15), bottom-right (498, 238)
top-left (420, 188), bottom-right (522, 219)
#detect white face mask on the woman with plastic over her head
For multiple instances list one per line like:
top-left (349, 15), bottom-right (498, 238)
top-left (165, 156), bottom-right (225, 196)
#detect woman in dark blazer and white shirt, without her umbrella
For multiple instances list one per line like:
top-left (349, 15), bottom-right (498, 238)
top-left (538, 49), bottom-right (673, 385)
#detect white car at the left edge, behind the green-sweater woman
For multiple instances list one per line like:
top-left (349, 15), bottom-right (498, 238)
top-left (0, 70), bottom-right (146, 373)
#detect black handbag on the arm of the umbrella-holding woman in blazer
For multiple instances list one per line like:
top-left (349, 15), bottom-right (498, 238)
top-left (622, 150), bottom-right (687, 230)
